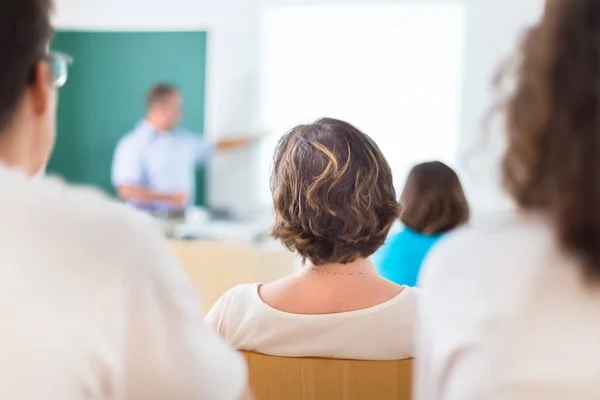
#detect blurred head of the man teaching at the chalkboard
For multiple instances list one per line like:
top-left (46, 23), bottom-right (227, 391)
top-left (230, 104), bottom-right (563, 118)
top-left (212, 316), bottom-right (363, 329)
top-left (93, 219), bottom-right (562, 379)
top-left (146, 83), bottom-right (183, 131)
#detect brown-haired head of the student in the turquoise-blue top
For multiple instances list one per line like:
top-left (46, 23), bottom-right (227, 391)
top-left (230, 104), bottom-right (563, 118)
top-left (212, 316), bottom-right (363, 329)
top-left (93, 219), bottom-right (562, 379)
top-left (400, 161), bottom-right (469, 235)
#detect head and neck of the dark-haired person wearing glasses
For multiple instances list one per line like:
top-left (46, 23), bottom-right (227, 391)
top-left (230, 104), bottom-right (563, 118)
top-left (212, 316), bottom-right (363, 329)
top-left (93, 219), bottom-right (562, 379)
top-left (0, 0), bottom-right (56, 175)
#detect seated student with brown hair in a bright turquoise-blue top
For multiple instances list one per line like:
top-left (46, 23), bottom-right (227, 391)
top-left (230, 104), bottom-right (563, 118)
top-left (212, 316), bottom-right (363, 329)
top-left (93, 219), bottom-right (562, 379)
top-left (373, 161), bottom-right (469, 286)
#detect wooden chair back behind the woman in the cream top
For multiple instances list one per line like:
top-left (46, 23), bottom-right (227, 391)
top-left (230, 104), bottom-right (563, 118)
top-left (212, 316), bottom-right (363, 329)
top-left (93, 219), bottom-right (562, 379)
top-left (243, 352), bottom-right (412, 400)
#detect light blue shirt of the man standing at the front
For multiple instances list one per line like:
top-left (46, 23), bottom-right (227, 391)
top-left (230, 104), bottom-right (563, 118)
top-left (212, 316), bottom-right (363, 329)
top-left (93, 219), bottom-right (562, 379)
top-left (112, 121), bottom-right (214, 212)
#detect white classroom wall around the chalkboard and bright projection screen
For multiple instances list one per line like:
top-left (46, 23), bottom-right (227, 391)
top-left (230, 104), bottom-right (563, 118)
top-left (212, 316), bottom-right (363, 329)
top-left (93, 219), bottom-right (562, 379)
top-left (55, 0), bottom-right (543, 217)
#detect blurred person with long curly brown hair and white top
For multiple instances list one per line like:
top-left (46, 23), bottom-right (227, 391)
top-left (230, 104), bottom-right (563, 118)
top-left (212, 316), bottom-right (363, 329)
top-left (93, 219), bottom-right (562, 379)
top-left (415, 0), bottom-right (600, 400)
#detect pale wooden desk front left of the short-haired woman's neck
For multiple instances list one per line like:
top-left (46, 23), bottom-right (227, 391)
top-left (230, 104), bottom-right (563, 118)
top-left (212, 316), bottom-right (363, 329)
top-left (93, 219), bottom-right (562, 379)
top-left (169, 240), bottom-right (296, 314)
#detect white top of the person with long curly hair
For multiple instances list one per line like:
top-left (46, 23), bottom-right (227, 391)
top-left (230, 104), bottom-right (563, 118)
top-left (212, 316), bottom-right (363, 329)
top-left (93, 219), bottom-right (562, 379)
top-left (415, 215), bottom-right (600, 400)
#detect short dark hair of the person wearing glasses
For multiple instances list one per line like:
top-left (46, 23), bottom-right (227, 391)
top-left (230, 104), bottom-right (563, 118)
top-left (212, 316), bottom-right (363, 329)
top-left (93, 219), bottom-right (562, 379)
top-left (0, 0), bottom-right (52, 132)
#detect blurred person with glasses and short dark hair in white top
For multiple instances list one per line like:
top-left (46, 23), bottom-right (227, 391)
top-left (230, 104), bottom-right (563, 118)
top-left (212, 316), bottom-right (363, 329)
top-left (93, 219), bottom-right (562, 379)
top-left (0, 0), bottom-right (247, 400)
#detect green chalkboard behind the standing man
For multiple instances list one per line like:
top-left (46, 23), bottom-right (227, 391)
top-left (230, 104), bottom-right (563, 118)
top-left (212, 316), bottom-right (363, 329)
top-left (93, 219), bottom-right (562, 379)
top-left (48, 31), bottom-right (206, 204)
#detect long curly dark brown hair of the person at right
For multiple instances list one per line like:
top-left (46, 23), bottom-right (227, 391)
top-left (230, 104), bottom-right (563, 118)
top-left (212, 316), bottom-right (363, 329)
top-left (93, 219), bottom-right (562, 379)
top-left (503, 0), bottom-right (600, 279)
